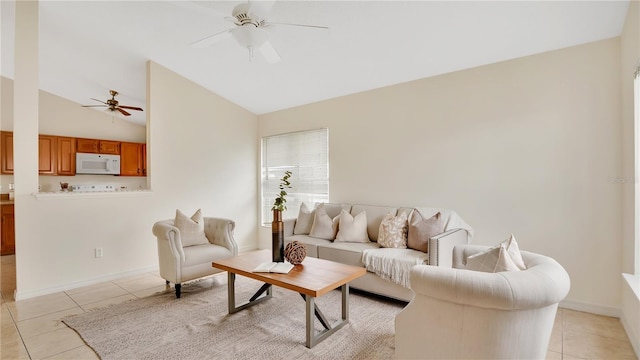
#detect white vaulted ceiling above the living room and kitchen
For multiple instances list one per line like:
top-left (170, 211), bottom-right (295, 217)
top-left (0, 0), bottom-right (629, 123)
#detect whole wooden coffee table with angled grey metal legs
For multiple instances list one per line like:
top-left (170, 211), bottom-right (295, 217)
top-left (213, 250), bottom-right (366, 348)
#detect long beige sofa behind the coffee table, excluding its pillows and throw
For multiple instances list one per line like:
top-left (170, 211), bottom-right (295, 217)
top-left (284, 204), bottom-right (473, 301)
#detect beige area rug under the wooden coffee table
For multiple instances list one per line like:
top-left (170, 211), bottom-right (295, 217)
top-left (63, 275), bottom-right (405, 360)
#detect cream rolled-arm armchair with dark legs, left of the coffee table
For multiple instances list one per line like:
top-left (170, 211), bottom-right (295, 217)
top-left (153, 217), bottom-right (238, 298)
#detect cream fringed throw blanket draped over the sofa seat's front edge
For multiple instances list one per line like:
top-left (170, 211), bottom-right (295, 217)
top-left (362, 248), bottom-right (429, 289)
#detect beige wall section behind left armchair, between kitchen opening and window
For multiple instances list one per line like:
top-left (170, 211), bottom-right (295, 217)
top-left (147, 62), bottom-right (259, 251)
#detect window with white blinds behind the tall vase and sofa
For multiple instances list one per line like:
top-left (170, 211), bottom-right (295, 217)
top-left (261, 129), bottom-right (329, 225)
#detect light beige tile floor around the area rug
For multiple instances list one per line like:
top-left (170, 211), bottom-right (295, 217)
top-left (0, 256), bottom-right (637, 360)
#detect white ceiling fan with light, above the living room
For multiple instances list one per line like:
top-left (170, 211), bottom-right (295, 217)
top-left (191, 1), bottom-right (328, 63)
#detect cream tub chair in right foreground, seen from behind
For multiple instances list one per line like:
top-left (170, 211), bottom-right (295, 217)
top-left (395, 245), bottom-right (570, 359)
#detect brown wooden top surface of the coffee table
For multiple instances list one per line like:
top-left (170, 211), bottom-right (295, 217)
top-left (212, 249), bottom-right (367, 297)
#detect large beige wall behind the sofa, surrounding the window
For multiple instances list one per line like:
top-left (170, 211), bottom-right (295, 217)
top-left (259, 38), bottom-right (622, 313)
